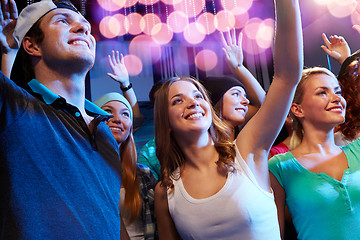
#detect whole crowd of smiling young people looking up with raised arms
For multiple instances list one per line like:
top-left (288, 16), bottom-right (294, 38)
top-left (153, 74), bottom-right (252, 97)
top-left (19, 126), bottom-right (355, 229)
top-left (0, 0), bottom-right (360, 240)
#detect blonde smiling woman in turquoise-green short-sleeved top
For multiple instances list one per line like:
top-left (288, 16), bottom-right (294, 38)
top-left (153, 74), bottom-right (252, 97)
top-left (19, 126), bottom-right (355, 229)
top-left (269, 67), bottom-right (360, 240)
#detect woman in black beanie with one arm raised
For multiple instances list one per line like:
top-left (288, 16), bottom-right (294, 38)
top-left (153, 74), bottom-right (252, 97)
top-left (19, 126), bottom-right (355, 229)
top-left (202, 29), bottom-right (265, 140)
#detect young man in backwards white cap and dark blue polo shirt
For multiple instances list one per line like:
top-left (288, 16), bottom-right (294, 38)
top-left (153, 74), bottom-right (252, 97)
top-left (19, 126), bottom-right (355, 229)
top-left (0, 0), bottom-right (121, 239)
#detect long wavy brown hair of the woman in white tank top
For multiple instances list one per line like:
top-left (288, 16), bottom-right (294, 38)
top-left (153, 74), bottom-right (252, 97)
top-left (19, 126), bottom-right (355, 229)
top-left (154, 77), bottom-right (236, 191)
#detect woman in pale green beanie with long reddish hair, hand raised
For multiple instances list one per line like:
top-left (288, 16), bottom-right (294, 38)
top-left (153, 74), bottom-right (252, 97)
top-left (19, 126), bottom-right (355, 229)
top-left (94, 51), bottom-right (157, 239)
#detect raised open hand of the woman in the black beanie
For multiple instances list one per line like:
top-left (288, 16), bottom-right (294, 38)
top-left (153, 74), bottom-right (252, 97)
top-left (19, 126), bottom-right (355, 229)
top-left (220, 29), bottom-right (244, 69)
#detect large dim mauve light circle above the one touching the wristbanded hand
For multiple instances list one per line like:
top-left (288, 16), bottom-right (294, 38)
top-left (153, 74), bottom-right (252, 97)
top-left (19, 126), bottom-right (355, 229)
top-left (129, 34), bottom-right (161, 64)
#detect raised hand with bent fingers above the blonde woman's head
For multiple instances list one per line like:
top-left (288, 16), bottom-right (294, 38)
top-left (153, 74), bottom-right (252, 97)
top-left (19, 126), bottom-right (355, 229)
top-left (321, 33), bottom-right (351, 65)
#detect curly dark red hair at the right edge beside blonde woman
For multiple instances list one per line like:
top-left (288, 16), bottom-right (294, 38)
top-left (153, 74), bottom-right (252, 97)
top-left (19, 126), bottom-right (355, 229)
top-left (335, 58), bottom-right (360, 140)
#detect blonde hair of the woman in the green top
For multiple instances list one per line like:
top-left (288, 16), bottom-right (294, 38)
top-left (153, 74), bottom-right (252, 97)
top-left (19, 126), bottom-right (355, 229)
top-left (290, 67), bottom-right (336, 149)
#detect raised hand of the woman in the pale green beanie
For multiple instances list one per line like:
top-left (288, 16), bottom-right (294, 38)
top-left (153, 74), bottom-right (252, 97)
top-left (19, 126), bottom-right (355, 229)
top-left (107, 50), bottom-right (130, 87)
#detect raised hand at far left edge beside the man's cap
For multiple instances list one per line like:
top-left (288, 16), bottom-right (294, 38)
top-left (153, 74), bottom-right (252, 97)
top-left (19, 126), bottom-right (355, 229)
top-left (0, 0), bottom-right (18, 54)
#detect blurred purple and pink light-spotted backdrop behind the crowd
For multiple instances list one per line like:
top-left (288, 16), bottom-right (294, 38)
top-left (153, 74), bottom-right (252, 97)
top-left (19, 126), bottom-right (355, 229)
top-left (16, 0), bottom-right (360, 148)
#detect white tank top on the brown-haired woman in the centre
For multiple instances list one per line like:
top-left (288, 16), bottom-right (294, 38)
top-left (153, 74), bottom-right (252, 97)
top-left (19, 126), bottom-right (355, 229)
top-left (168, 148), bottom-right (280, 240)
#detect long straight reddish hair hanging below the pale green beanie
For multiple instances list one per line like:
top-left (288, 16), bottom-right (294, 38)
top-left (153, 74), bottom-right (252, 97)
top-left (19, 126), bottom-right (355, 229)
top-left (119, 127), bottom-right (142, 223)
